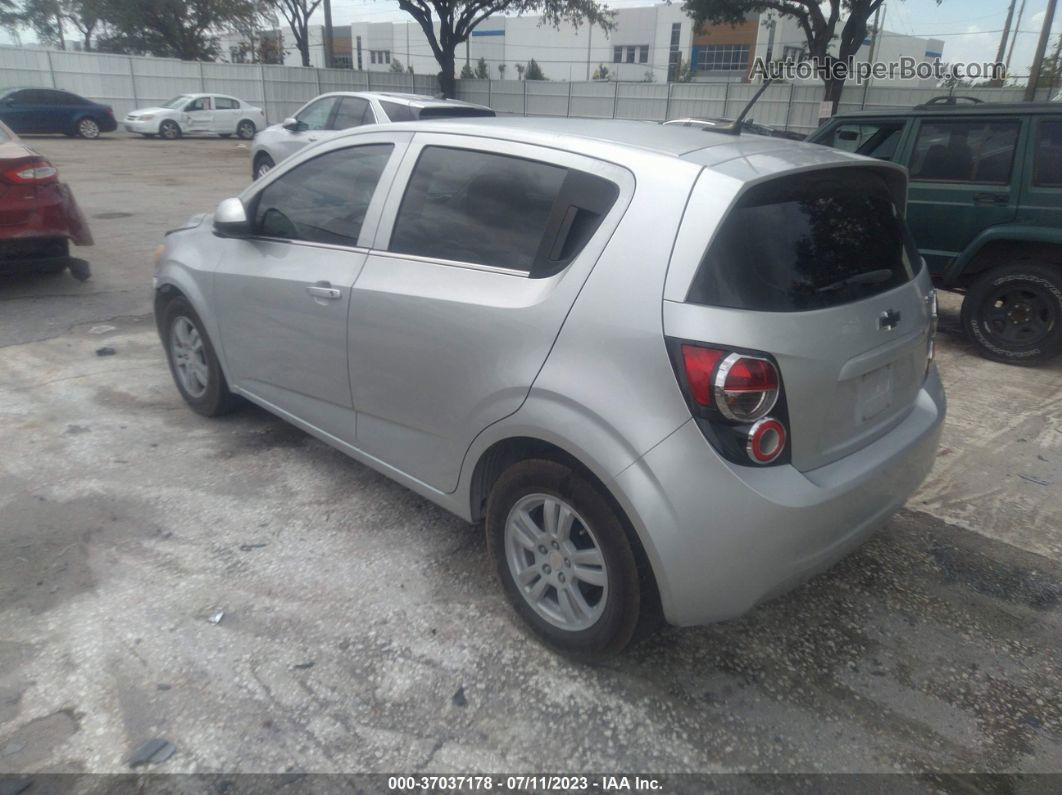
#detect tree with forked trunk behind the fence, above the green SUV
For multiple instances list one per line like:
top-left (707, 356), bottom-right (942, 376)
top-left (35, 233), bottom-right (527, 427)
top-left (682, 0), bottom-right (941, 113)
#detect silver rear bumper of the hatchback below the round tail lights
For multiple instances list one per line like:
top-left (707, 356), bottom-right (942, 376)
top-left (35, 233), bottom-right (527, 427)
top-left (613, 368), bottom-right (945, 625)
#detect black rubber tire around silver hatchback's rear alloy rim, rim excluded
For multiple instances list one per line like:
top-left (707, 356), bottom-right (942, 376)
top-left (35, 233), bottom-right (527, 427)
top-left (485, 460), bottom-right (652, 661)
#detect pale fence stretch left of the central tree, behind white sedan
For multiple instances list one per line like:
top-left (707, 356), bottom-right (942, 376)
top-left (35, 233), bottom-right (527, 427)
top-left (0, 47), bottom-right (439, 122)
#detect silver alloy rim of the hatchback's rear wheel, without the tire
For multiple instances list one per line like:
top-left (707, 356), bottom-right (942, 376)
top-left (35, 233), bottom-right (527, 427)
top-left (506, 494), bottom-right (609, 632)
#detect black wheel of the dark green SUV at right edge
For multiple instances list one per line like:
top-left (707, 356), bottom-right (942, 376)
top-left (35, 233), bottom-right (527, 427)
top-left (962, 260), bottom-right (1062, 365)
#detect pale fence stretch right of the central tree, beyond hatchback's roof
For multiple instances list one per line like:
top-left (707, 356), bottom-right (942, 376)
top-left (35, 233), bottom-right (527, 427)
top-left (457, 80), bottom-right (1050, 133)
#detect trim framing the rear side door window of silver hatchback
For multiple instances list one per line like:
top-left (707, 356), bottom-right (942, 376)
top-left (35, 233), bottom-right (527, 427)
top-left (384, 143), bottom-right (622, 279)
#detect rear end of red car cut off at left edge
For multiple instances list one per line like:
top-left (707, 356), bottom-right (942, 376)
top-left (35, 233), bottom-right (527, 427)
top-left (0, 122), bottom-right (92, 273)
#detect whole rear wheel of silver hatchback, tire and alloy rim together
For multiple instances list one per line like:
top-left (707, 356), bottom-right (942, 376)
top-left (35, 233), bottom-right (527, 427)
top-left (486, 460), bottom-right (643, 659)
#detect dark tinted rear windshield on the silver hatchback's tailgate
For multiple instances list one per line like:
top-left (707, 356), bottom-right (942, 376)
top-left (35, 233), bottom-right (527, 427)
top-left (687, 171), bottom-right (921, 312)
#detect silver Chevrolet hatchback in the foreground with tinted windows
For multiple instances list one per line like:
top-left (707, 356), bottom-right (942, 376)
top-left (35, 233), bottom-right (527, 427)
top-left (155, 119), bottom-right (945, 658)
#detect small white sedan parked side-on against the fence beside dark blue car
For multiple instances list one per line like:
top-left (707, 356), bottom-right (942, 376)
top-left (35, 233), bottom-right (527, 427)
top-left (122, 93), bottom-right (266, 140)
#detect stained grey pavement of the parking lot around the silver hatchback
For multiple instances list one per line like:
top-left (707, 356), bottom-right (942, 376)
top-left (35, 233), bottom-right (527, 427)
top-left (0, 134), bottom-right (1062, 774)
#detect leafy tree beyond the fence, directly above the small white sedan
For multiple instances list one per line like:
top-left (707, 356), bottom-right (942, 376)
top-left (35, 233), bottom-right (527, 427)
top-left (98, 0), bottom-right (254, 61)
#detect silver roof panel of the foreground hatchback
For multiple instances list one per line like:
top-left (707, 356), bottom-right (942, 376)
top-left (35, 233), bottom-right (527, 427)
top-left (332, 116), bottom-right (866, 168)
